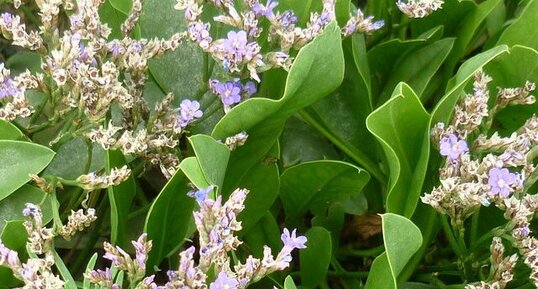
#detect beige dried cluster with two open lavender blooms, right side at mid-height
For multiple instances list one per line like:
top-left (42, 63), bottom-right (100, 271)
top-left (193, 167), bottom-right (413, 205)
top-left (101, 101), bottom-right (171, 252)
top-left (422, 71), bottom-right (538, 223)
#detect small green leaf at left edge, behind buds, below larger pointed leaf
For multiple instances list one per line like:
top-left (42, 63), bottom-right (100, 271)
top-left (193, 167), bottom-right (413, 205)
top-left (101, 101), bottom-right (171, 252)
top-left (0, 185), bottom-right (52, 231)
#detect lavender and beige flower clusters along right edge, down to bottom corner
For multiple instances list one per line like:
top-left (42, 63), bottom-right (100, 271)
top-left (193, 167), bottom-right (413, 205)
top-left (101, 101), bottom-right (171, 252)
top-left (422, 71), bottom-right (538, 288)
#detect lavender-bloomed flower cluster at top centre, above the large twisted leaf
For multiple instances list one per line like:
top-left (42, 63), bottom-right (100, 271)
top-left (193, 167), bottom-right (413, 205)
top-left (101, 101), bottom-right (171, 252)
top-left (175, 0), bottom-right (383, 112)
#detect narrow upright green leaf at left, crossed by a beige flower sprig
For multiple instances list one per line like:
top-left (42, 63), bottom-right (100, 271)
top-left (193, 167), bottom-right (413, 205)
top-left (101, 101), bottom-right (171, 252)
top-left (105, 150), bottom-right (136, 247)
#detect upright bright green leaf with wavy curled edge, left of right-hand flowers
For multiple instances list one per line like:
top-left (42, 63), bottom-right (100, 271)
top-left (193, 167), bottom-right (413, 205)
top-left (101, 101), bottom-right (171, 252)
top-left (366, 83), bottom-right (430, 217)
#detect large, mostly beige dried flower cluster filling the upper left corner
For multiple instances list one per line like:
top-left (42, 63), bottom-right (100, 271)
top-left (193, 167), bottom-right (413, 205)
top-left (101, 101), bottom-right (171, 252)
top-left (0, 0), bottom-right (192, 177)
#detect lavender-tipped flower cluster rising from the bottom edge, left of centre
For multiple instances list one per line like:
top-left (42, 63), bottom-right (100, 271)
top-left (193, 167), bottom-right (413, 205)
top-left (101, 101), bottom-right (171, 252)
top-left (85, 186), bottom-right (307, 289)
